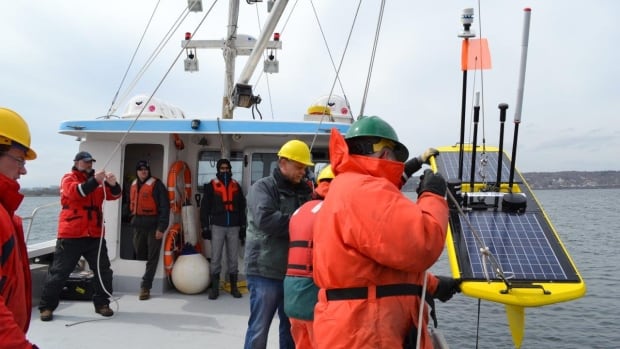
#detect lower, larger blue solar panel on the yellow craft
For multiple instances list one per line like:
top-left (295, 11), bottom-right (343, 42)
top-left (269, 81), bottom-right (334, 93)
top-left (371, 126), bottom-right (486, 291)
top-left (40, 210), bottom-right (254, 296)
top-left (450, 211), bottom-right (579, 282)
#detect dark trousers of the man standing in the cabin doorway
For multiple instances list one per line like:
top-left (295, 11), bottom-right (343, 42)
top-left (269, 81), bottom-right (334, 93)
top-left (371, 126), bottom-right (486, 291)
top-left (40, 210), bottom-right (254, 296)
top-left (133, 227), bottom-right (163, 290)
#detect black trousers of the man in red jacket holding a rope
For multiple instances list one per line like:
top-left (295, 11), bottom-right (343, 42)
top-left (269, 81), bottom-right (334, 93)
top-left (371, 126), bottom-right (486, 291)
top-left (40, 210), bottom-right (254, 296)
top-left (39, 238), bottom-right (112, 310)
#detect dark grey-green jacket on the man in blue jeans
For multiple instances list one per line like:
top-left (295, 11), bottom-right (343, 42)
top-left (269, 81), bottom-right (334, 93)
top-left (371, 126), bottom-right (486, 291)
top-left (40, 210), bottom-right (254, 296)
top-left (245, 167), bottom-right (312, 280)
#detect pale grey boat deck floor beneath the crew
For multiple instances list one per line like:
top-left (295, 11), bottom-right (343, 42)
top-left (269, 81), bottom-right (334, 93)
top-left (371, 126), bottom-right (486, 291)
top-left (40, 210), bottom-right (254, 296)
top-left (28, 291), bottom-right (279, 349)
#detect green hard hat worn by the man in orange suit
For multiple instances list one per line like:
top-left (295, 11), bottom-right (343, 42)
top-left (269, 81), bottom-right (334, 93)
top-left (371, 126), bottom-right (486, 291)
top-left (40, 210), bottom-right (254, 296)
top-left (344, 116), bottom-right (409, 162)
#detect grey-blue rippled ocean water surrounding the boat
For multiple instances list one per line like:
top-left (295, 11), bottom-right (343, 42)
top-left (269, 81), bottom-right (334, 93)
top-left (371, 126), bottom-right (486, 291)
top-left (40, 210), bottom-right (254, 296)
top-left (18, 189), bottom-right (620, 349)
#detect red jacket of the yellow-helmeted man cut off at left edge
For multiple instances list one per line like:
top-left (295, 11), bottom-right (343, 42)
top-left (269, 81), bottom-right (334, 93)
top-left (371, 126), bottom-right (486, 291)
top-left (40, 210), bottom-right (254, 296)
top-left (0, 174), bottom-right (32, 349)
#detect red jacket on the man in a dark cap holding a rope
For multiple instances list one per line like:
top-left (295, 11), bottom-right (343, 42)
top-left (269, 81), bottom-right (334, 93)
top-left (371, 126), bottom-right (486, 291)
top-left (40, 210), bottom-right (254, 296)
top-left (58, 167), bottom-right (121, 239)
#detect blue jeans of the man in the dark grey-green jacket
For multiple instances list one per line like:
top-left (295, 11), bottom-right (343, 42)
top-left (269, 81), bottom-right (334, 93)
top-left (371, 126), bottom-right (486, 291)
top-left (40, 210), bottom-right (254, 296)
top-left (243, 275), bottom-right (295, 349)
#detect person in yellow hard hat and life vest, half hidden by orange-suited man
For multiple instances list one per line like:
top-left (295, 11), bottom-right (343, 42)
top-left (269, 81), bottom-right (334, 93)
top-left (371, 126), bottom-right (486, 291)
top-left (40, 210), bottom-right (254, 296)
top-left (284, 165), bottom-right (334, 349)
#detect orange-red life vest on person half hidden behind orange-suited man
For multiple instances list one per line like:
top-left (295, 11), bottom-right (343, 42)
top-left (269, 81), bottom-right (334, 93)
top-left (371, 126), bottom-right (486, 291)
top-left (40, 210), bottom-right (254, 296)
top-left (286, 200), bottom-right (323, 278)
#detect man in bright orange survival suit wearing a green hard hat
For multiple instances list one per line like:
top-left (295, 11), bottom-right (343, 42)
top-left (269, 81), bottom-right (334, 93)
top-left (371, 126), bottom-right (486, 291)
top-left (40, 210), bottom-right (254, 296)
top-left (313, 116), bottom-right (458, 349)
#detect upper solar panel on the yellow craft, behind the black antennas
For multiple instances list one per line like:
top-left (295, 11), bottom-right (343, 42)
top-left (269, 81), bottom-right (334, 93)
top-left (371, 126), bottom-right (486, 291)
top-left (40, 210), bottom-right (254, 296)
top-left (436, 151), bottom-right (517, 183)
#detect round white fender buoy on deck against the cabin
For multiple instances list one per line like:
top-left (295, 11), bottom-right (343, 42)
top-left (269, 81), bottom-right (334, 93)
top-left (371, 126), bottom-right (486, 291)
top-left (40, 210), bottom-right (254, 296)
top-left (172, 247), bottom-right (209, 294)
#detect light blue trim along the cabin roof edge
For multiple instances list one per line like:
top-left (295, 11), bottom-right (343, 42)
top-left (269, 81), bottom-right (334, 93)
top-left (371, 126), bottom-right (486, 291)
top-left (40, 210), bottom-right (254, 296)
top-left (58, 119), bottom-right (350, 134)
